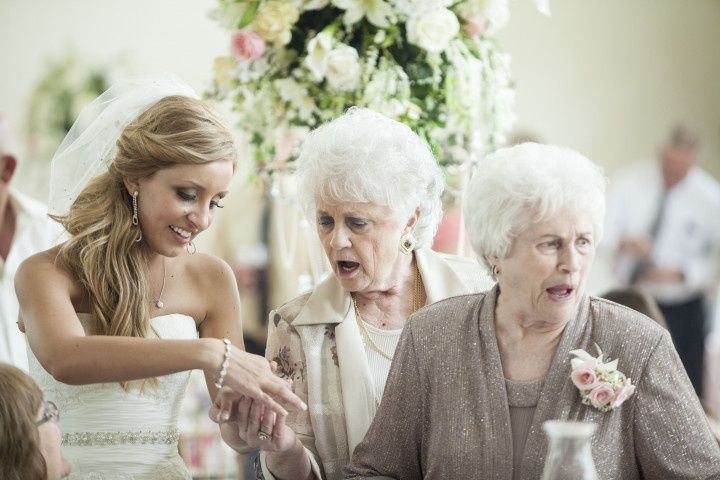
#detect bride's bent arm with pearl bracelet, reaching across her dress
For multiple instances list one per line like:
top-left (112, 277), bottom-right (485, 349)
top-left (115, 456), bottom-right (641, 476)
top-left (15, 254), bottom-right (302, 411)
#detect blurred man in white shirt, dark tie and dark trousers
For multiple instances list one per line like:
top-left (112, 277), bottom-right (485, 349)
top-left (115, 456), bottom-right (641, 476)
top-left (606, 127), bottom-right (720, 396)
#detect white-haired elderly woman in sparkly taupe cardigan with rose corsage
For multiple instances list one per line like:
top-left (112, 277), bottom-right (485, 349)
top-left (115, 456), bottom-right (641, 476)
top-left (345, 143), bottom-right (720, 480)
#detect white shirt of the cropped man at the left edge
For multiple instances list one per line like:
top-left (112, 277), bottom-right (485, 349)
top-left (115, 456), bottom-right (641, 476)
top-left (0, 189), bottom-right (64, 371)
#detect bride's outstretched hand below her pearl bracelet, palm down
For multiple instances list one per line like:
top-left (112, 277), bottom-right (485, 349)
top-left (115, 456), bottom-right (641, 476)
top-left (211, 345), bottom-right (307, 416)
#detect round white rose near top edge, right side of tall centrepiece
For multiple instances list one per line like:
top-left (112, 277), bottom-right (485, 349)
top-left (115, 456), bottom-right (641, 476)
top-left (407, 8), bottom-right (460, 53)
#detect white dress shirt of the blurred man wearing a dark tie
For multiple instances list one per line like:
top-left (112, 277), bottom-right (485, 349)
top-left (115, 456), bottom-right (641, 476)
top-left (604, 161), bottom-right (720, 304)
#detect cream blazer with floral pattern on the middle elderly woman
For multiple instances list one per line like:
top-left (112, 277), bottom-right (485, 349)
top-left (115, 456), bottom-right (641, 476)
top-left (260, 249), bottom-right (492, 480)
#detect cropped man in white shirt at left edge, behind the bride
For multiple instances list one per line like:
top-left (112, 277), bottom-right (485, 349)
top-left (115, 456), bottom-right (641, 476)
top-left (0, 113), bottom-right (62, 371)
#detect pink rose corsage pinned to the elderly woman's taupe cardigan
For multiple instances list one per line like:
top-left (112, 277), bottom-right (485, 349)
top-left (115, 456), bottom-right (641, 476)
top-left (570, 345), bottom-right (635, 412)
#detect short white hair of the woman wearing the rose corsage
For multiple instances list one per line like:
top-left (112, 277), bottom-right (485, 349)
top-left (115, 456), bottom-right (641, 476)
top-left (463, 143), bottom-right (607, 270)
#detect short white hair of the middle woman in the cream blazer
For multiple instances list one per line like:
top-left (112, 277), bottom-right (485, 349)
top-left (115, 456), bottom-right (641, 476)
top-left (297, 107), bottom-right (445, 247)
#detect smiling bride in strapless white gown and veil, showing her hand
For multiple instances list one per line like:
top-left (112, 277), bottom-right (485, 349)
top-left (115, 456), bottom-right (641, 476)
top-left (15, 75), bottom-right (305, 479)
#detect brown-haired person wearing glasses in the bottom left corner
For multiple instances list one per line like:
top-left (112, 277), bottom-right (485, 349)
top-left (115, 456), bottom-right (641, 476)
top-left (0, 363), bottom-right (70, 480)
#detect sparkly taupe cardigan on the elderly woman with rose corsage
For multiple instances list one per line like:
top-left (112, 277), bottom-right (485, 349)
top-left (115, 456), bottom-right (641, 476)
top-left (346, 289), bottom-right (720, 480)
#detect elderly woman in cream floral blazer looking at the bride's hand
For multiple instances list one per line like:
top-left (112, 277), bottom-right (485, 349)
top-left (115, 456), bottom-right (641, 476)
top-left (217, 108), bottom-right (491, 479)
